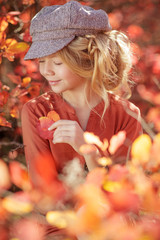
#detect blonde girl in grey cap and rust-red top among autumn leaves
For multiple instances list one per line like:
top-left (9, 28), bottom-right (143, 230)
top-left (22, 1), bottom-right (142, 238)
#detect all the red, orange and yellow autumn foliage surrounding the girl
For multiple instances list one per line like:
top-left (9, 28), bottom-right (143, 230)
top-left (0, 0), bottom-right (160, 240)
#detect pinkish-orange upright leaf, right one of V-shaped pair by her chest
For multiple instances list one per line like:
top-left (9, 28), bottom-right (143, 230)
top-left (108, 131), bottom-right (126, 154)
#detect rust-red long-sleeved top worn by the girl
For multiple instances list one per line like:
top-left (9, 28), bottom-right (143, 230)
top-left (22, 92), bottom-right (142, 182)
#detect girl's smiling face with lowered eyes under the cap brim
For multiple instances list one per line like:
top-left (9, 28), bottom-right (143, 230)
top-left (39, 54), bottom-right (85, 93)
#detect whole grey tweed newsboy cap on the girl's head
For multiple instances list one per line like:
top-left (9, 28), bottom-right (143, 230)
top-left (24, 1), bottom-right (111, 60)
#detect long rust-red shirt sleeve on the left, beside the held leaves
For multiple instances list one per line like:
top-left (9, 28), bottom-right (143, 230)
top-left (21, 102), bottom-right (57, 188)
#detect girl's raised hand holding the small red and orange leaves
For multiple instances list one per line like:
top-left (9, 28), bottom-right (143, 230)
top-left (48, 120), bottom-right (85, 153)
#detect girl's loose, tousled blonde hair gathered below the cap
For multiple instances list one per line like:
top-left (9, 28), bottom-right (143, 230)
top-left (58, 30), bottom-right (132, 117)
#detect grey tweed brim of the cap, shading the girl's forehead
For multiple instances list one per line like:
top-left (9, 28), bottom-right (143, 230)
top-left (24, 36), bottom-right (75, 60)
